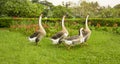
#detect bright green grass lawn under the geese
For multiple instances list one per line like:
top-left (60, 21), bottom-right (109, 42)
top-left (0, 30), bottom-right (120, 64)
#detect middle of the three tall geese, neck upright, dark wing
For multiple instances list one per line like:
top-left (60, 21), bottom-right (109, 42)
top-left (51, 15), bottom-right (68, 44)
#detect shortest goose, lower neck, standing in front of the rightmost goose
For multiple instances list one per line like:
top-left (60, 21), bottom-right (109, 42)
top-left (63, 28), bottom-right (84, 49)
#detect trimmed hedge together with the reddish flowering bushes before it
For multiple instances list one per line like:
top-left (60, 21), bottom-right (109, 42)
top-left (0, 17), bottom-right (120, 36)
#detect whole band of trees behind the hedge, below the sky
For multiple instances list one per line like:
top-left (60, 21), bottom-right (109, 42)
top-left (0, 0), bottom-right (120, 18)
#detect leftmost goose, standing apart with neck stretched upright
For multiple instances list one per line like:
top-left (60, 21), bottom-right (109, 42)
top-left (29, 14), bottom-right (46, 45)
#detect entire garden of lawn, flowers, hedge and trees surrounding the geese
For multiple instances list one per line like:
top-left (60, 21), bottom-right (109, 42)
top-left (0, 0), bottom-right (120, 64)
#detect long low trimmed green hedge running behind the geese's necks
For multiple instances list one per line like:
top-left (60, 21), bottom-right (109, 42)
top-left (0, 18), bottom-right (120, 27)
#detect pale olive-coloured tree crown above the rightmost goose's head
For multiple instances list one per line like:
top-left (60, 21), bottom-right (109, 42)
top-left (73, 1), bottom-right (101, 17)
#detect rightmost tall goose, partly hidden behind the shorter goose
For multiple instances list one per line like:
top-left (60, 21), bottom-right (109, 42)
top-left (83, 15), bottom-right (91, 42)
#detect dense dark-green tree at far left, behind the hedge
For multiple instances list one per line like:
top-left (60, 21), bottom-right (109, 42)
top-left (0, 0), bottom-right (43, 17)
